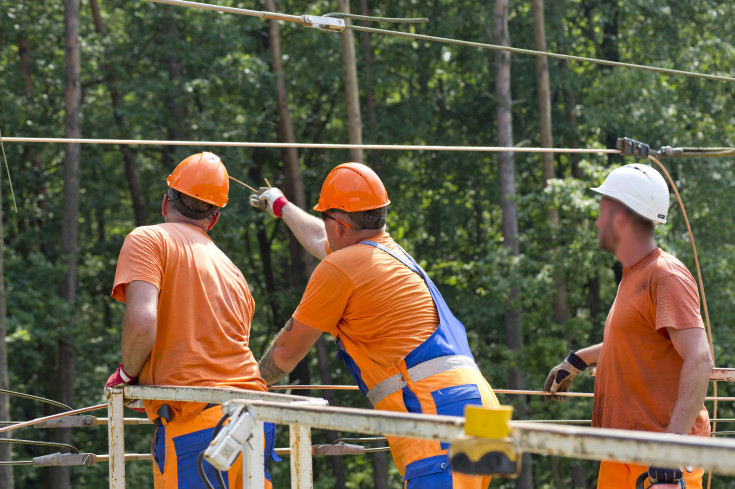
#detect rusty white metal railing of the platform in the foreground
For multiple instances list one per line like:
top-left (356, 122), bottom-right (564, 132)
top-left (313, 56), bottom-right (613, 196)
top-left (108, 385), bottom-right (735, 489)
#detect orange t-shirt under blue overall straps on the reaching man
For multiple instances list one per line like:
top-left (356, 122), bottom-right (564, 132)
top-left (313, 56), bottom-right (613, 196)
top-left (293, 233), bottom-right (439, 386)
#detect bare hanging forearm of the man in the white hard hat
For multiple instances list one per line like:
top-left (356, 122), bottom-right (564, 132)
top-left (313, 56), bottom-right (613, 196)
top-left (666, 328), bottom-right (714, 435)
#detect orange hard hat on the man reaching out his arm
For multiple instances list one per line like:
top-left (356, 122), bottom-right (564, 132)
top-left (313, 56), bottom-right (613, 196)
top-left (314, 163), bottom-right (390, 212)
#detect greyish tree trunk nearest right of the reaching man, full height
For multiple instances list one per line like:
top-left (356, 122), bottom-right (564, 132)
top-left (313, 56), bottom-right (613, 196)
top-left (493, 0), bottom-right (533, 489)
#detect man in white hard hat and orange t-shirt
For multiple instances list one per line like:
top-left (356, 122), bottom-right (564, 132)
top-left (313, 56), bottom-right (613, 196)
top-left (544, 164), bottom-right (713, 489)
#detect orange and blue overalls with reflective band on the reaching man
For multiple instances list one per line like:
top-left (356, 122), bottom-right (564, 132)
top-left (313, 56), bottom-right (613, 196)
top-left (337, 241), bottom-right (499, 489)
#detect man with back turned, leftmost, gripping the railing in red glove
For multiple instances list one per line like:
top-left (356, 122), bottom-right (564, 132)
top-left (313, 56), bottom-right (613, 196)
top-left (105, 152), bottom-right (275, 489)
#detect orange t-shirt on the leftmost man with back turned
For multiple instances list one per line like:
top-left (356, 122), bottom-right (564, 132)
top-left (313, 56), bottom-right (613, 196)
top-left (112, 223), bottom-right (267, 419)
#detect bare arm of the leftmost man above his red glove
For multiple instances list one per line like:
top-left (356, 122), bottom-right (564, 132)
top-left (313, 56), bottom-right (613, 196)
top-left (122, 280), bottom-right (158, 376)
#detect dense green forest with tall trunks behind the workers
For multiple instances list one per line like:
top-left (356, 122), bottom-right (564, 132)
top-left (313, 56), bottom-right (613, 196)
top-left (0, 0), bottom-right (735, 489)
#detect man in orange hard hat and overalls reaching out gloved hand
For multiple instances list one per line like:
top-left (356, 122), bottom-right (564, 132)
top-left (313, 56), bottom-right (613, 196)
top-left (251, 163), bottom-right (498, 489)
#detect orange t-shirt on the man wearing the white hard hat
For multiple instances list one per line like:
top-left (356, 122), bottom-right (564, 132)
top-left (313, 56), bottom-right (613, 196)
top-left (592, 248), bottom-right (709, 436)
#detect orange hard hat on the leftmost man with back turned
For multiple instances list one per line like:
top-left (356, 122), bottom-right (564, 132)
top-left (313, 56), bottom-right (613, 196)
top-left (166, 151), bottom-right (230, 207)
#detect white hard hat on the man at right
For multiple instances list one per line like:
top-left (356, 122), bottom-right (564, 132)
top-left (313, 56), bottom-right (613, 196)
top-left (590, 164), bottom-right (669, 224)
